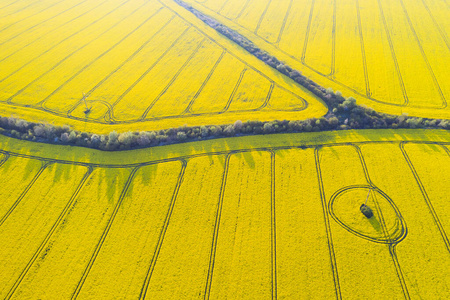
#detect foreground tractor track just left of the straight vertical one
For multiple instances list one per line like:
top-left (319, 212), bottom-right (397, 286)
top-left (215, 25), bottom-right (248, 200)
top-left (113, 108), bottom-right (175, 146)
top-left (203, 153), bottom-right (233, 299)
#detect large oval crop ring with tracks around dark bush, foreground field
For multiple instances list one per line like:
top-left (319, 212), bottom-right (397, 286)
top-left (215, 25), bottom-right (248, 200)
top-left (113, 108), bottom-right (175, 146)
top-left (328, 185), bottom-right (407, 244)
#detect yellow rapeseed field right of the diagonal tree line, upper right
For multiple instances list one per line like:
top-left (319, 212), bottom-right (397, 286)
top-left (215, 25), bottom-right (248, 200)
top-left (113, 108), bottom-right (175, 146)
top-left (186, 0), bottom-right (450, 118)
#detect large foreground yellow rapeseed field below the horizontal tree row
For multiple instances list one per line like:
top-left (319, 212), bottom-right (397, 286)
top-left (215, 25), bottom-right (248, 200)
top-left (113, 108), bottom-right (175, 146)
top-left (0, 130), bottom-right (450, 299)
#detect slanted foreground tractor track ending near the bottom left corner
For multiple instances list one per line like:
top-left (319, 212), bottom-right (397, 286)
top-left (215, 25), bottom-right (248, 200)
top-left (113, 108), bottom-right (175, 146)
top-left (5, 167), bottom-right (93, 299)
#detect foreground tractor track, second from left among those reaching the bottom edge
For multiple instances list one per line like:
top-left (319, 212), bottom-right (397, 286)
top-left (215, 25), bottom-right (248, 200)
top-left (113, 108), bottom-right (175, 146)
top-left (71, 166), bottom-right (140, 299)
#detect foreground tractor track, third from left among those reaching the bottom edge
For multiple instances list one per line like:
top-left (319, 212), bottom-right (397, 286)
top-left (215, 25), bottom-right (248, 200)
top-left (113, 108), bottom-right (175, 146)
top-left (139, 159), bottom-right (187, 299)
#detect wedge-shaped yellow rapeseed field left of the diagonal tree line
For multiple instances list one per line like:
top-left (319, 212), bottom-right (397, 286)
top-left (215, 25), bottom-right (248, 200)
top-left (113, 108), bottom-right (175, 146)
top-left (0, 0), bottom-right (326, 133)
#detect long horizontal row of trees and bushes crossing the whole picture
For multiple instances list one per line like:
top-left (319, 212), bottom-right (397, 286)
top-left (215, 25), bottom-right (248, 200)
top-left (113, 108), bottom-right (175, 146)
top-left (0, 102), bottom-right (450, 151)
